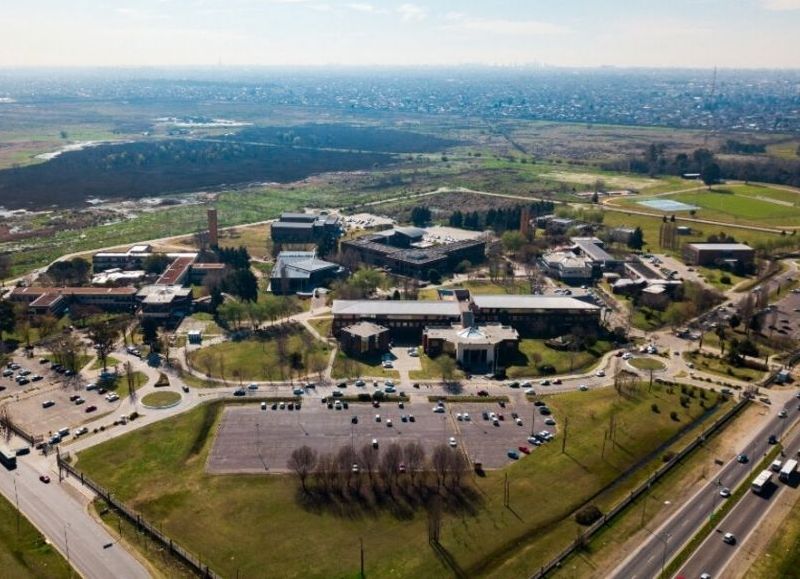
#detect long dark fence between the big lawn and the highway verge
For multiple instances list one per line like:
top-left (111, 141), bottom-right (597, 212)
top-left (530, 398), bottom-right (750, 579)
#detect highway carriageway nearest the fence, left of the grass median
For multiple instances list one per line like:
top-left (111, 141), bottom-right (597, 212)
top-left (611, 399), bottom-right (800, 579)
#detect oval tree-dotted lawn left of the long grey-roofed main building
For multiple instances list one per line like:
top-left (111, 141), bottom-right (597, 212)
top-left (189, 327), bottom-right (329, 382)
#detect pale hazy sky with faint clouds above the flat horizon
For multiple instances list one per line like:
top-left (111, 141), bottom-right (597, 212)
top-left (0, 0), bottom-right (800, 68)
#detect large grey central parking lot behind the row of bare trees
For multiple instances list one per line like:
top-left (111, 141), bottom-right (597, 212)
top-left (207, 400), bottom-right (556, 473)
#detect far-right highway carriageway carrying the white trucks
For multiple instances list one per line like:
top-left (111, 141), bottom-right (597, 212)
top-left (677, 420), bottom-right (800, 577)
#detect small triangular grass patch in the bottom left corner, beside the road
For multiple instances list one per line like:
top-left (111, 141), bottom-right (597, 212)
top-left (0, 495), bottom-right (74, 579)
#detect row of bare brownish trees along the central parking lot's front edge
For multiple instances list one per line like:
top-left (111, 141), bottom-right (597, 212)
top-left (287, 442), bottom-right (469, 496)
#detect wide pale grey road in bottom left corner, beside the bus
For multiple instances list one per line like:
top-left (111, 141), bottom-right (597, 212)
top-left (0, 454), bottom-right (150, 579)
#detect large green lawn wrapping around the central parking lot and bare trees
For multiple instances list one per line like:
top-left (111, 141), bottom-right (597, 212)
top-left (78, 388), bottom-right (720, 578)
